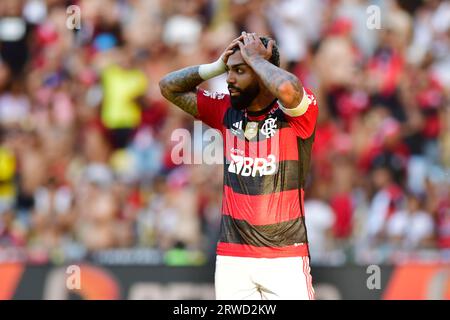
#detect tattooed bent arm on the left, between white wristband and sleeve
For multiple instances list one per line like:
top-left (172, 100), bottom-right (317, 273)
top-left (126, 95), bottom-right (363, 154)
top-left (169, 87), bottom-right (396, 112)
top-left (159, 66), bottom-right (204, 116)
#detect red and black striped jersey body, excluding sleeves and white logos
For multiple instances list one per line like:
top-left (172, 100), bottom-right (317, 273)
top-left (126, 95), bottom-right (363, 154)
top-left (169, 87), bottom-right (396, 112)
top-left (217, 102), bottom-right (312, 257)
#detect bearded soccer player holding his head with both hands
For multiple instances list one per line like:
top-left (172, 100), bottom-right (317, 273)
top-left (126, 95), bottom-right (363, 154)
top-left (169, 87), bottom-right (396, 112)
top-left (160, 32), bottom-right (318, 299)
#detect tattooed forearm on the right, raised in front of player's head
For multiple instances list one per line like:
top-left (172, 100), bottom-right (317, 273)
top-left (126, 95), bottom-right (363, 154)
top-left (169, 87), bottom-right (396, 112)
top-left (249, 58), bottom-right (303, 108)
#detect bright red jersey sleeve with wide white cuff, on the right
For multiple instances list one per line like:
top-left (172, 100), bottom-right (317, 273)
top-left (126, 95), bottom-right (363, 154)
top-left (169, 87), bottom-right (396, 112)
top-left (280, 89), bottom-right (319, 139)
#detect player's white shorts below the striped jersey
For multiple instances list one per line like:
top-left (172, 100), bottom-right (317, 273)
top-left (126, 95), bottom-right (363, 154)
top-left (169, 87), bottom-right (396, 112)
top-left (215, 256), bottom-right (314, 300)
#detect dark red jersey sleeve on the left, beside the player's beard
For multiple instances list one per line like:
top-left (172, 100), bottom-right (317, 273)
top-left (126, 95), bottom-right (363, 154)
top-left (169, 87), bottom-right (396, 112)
top-left (195, 89), bottom-right (230, 131)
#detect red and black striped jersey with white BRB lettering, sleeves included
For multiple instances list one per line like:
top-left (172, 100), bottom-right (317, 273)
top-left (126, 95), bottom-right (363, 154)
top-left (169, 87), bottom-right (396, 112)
top-left (197, 89), bottom-right (318, 258)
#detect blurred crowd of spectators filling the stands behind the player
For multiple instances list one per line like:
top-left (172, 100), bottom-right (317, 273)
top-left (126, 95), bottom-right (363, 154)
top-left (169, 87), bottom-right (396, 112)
top-left (0, 0), bottom-right (450, 264)
